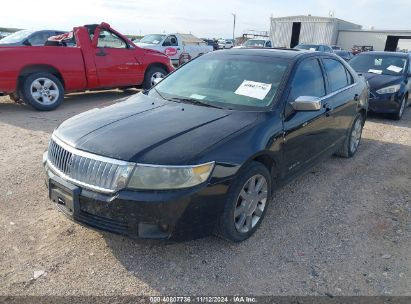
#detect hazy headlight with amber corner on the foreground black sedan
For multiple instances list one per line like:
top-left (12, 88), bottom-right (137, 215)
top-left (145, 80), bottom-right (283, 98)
top-left (128, 162), bottom-right (214, 190)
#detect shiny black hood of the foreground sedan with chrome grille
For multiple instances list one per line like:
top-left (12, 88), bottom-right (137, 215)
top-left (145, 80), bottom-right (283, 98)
top-left (54, 94), bottom-right (258, 165)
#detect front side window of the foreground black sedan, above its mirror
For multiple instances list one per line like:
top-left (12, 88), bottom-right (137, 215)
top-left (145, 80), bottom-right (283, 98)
top-left (289, 59), bottom-right (325, 102)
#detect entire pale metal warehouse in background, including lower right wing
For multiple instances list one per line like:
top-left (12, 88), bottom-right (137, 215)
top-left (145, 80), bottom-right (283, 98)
top-left (270, 15), bottom-right (411, 51)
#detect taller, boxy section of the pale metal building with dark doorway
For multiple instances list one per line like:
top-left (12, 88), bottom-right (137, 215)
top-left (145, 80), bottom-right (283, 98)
top-left (270, 16), bottom-right (362, 47)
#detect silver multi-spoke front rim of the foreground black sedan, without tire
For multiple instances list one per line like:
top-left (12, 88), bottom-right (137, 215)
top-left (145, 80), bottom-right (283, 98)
top-left (234, 174), bottom-right (268, 233)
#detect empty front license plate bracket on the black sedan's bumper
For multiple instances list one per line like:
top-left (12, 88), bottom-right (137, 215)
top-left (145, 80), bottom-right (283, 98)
top-left (49, 177), bottom-right (81, 216)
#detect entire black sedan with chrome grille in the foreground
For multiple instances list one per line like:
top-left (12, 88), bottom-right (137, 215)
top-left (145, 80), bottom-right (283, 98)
top-left (43, 49), bottom-right (368, 242)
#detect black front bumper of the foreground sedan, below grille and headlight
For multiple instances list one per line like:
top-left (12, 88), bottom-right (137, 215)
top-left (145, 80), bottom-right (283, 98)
top-left (44, 163), bottom-right (232, 241)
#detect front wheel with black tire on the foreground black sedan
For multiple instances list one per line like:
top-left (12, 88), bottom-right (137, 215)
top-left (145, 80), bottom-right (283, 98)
top-left (217, 161), bottom-right (272, 242)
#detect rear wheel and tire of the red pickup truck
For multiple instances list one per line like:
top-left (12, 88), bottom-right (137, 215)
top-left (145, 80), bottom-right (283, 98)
top-left (21, 72), bottom-right (64, 111)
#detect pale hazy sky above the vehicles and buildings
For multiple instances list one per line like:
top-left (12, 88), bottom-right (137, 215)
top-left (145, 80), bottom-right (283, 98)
top-left (0, 0), bottom-right (411, 38)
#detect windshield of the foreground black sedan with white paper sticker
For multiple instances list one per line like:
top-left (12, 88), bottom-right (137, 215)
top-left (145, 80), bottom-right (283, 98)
top-left (148, 53), bottom-right (289, 110)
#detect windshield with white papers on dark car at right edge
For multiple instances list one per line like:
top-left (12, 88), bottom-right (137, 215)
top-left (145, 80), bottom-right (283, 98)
top-left (350, 54), bottom-right (407, 75)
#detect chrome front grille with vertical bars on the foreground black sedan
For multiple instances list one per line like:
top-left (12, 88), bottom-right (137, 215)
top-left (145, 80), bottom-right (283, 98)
top-left (47, 137), bottom-right (134, 193)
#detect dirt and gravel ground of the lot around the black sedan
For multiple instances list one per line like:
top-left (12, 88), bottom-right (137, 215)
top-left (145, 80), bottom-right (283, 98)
top-left (0, 91), bottom-right (411, 295)
